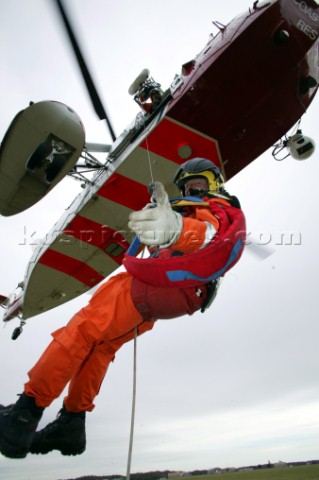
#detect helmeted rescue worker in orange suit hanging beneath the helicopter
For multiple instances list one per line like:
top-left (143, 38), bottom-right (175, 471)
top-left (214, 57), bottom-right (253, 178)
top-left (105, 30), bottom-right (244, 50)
top-left (0, 158), bottom-right (244, 458)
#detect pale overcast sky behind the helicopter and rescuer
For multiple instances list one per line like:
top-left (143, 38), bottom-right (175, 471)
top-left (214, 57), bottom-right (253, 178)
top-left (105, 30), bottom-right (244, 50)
top-left (0, 0), bottom-right (319, 480)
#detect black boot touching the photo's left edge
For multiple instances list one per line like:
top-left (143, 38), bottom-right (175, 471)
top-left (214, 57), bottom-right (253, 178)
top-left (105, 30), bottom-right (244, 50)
top-left (0, 393), bottom-right (44, 458)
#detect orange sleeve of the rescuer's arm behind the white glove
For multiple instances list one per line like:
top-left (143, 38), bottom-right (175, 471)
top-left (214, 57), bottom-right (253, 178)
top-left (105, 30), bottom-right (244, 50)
top-left (170, 208), bottom-right (219, 253)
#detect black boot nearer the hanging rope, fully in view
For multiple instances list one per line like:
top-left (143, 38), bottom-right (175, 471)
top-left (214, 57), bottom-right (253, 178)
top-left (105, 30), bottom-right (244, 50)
top-left (30, 406), bottom-right (86, 455)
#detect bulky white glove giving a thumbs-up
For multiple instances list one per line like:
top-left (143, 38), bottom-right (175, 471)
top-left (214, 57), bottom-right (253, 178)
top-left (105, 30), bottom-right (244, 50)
top-left (128, 182), bottom-right (183, 247)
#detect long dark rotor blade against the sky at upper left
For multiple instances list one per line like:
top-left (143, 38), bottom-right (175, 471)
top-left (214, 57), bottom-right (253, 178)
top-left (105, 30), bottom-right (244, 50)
top-left (56, 0), bottom-right (116, 142)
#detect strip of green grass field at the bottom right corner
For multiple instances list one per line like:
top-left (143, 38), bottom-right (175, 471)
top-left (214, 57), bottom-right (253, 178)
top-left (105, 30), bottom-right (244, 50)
top-left (190, 465), bottom-right (319, 480)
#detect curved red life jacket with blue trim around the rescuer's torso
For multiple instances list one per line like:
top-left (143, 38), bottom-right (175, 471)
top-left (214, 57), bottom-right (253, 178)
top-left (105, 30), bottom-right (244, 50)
top-left (124, 199), bottom-right (246, 288)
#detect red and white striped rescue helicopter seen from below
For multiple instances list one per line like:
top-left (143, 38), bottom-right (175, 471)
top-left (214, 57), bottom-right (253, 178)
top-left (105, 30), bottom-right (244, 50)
top-left (0, 0), bottom-right (319, 338)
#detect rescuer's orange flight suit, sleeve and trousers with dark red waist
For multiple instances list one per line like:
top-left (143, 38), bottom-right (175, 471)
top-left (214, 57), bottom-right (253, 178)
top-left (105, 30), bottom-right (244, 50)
top-left (25, 208), bottom-right (218, 412)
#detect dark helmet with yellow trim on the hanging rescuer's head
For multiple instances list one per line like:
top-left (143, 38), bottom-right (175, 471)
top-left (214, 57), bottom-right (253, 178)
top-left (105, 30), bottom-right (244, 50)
top-left (174, 158), bottom-right (224, 195)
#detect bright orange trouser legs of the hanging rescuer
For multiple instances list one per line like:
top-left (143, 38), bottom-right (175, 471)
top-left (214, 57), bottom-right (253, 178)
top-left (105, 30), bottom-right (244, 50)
top-left (25, 273), bottom-right (154, 412)
